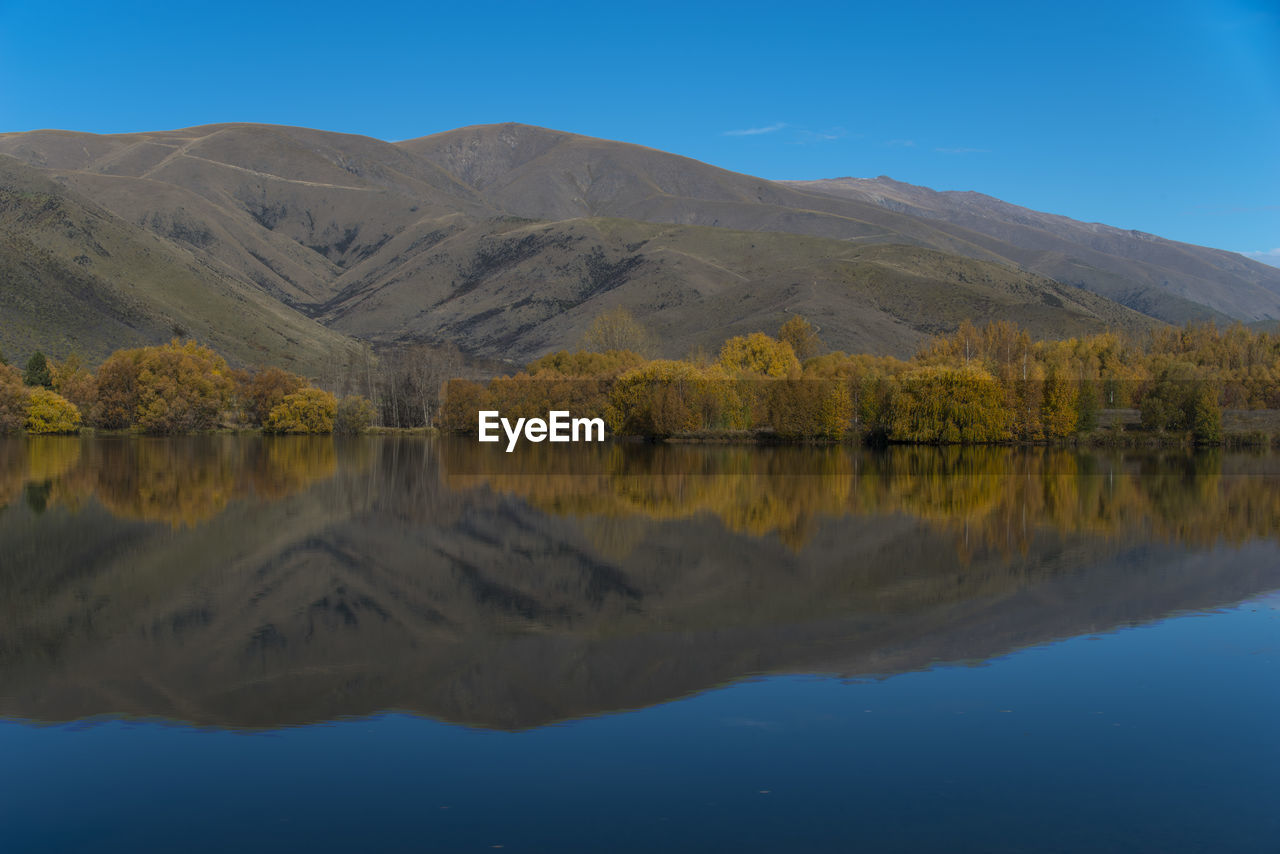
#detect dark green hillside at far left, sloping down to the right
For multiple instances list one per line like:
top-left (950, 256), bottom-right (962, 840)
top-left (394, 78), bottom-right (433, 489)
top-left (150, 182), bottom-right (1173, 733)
top-left (0, 157), bottom-right (353, 374)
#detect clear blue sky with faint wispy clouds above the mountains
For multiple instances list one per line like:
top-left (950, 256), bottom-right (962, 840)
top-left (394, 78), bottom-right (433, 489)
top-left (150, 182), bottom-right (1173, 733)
top-left (0, 0), bottom-right (1280, 262)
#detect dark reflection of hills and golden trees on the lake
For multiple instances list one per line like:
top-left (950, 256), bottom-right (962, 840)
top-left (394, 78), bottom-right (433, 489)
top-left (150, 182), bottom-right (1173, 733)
top-left (0, 437), bottom-right (1280, 729)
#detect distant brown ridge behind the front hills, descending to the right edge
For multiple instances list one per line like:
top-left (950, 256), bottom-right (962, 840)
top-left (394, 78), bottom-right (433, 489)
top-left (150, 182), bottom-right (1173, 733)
top-left (398, 124), bottom-right (1280, 323)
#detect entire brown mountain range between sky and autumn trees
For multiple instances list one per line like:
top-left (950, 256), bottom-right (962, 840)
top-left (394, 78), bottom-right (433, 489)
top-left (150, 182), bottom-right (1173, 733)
top-left (0, 124), bottom-right (1280, 375)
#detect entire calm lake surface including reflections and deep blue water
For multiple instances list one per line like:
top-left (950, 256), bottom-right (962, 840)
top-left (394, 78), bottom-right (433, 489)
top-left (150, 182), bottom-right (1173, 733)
top-left (0, 437), bottom-right (1280, 854)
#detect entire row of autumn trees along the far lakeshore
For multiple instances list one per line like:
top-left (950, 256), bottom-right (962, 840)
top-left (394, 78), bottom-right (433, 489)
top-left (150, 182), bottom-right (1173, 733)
top-left (10, 316), bottom-right (1280, 444)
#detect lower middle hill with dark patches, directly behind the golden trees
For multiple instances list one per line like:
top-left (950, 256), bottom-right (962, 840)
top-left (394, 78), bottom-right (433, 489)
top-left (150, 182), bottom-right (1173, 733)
top-left (319, 219), bottom-right (1156, 362)
